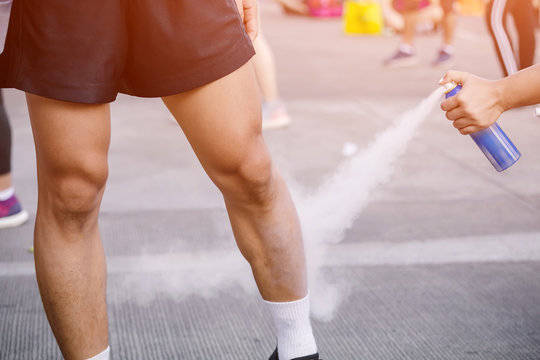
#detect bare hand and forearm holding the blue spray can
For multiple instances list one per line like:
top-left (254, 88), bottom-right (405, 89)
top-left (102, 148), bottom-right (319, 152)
top-left (440, 65), bottom-right (540, 135)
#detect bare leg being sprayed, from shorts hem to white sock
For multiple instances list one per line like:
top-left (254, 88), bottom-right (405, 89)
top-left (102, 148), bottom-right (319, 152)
top-left (163, 63), bottom-right (307, 302)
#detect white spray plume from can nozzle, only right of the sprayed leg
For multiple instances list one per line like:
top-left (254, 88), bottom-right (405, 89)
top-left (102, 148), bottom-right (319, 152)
top-left (297, 88), bottom-right (443, 321)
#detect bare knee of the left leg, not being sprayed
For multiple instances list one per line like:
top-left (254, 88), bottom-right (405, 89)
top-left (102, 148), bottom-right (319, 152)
top-left (45, 160), bottom-right (108, 221)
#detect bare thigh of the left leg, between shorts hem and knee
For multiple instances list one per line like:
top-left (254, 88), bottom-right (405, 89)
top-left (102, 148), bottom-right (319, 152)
top-left (27, 94), bottom-right (110, 181)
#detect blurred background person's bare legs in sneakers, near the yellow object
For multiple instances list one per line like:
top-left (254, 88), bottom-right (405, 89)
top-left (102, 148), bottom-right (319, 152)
top-left (383, 0), bottom-right (456, 67)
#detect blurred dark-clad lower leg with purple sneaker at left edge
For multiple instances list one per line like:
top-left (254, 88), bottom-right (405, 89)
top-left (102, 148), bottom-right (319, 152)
top-left (0, 90), bottom-right (28, 229)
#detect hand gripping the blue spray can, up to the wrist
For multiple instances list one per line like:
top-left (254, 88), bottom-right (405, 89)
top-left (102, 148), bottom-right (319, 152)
top-left (439, 71), bottom-right (505, 135)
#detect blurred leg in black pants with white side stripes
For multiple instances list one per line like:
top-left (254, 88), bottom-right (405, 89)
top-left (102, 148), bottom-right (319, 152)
top-left (486, 0), bottom-right (536, 76)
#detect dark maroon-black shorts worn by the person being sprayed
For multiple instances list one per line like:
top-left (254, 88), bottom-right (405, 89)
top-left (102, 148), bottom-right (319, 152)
top-left (0, 0), bottom-right (254, 103)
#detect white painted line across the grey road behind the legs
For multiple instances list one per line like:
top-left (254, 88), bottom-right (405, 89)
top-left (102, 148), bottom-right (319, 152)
top-left (0, 233), bottom-right (540, 277)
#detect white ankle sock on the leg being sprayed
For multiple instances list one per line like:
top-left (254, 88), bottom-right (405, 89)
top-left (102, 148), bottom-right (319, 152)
top-left (264, 295), bottom-right (317, 360)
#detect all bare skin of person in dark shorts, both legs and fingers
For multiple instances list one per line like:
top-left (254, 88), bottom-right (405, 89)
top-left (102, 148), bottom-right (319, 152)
top-left (27, 0), bottom-right (307, 360)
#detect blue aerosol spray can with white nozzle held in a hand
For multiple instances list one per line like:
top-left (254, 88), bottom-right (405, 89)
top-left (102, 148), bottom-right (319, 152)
top-left (444, 82), bottom-right (521, 171)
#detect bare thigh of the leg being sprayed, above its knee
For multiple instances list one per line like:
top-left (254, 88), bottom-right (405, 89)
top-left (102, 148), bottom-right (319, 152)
top-left (163, 62), bottom-right (266, 177)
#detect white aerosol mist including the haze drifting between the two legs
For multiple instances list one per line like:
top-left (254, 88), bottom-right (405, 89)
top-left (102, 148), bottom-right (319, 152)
top-left (113, 89), bottom-right (442, 320)
